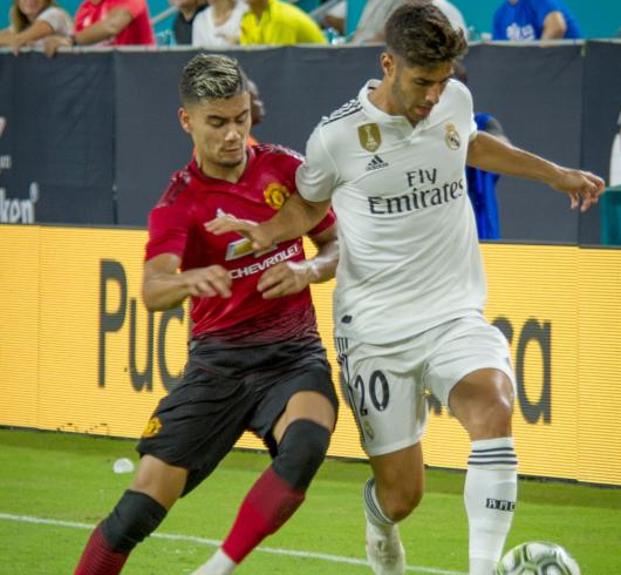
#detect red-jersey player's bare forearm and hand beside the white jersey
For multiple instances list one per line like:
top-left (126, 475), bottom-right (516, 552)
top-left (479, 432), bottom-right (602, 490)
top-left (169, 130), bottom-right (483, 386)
top-left (257, 225), bottom-right (339, 299)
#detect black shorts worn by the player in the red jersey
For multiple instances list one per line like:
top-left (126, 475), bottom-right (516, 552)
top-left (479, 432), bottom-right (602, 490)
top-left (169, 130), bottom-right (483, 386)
top-left (136, 338), bottom-right (338, 495)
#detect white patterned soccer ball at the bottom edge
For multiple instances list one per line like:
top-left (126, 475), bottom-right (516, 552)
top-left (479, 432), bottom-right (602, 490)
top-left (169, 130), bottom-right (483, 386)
top-left (494, 541), bottom-right (580, 575)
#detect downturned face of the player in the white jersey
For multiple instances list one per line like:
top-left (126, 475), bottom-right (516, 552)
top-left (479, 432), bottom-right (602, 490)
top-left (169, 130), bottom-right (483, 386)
top-left (384, 54), bottom-right (453, 125)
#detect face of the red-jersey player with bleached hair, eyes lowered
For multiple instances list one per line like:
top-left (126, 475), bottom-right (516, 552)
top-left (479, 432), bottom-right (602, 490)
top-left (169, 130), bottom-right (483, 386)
top-left (179, 92), bottom-right (250, 168)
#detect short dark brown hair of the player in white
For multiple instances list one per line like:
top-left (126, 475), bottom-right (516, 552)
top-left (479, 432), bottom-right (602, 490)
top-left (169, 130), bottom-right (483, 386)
top-left (385, 0), bottom-right (468, 67)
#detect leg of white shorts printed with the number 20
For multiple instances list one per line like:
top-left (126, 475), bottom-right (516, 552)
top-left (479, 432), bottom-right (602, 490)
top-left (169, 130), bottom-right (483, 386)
top-left (337, 338), bottom-right (427, 457)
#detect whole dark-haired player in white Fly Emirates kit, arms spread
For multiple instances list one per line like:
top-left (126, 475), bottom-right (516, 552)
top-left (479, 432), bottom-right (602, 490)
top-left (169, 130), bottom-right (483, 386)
top-left (207, 1), bottom-right (604, 575)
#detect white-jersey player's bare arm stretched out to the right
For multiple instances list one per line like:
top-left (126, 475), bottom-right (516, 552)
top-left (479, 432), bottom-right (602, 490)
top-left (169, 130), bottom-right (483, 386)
top-left (466, 132), bottom-right (604, 212)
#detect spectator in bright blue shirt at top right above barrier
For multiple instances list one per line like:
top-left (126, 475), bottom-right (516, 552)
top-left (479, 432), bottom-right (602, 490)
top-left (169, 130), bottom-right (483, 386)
top-left (492, 0), bottom-right (582, 40)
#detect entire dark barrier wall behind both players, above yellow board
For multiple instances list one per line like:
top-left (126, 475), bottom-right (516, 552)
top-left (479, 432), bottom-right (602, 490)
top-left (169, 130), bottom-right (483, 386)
top-left (0, 42), bottom-right (621, 243)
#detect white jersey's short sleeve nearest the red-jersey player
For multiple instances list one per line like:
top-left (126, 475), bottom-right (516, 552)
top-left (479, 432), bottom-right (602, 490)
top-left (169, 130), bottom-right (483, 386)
top-left (295, 126), bottom-right (339, 202)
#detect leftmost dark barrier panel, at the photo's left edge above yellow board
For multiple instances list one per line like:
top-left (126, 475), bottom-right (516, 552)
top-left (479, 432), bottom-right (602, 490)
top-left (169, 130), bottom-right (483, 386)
top-left (0, 52), bottom-right (115, 224)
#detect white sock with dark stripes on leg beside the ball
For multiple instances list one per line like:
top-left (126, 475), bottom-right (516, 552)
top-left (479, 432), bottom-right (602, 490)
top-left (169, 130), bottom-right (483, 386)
top-left (464, 437), bottom-right (517, 575)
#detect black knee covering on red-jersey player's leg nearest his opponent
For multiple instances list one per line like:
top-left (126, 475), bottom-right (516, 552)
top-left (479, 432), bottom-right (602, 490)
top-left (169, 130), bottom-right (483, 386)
top-left (272, 419), bottom-right (331, 491)
